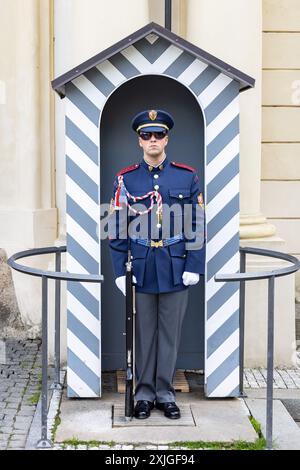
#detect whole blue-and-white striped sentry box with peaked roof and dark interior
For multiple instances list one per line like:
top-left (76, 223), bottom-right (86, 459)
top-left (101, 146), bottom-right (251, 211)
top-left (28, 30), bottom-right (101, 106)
top-left (52, 23), bottom-right (254, 397)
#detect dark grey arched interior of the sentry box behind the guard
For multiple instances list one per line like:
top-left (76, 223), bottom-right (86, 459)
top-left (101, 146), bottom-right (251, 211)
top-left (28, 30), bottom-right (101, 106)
top-left (100, 75), bottom-right (205, 382)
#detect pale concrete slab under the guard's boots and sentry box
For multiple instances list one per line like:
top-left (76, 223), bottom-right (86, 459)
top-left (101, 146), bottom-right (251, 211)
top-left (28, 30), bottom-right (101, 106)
top-left (55, 393), bottom-right (257, 444)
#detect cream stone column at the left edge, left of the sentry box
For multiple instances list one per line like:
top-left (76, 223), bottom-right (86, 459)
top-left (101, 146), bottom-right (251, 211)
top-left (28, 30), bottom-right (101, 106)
top-left (0, 0), bottom-right (57, 332)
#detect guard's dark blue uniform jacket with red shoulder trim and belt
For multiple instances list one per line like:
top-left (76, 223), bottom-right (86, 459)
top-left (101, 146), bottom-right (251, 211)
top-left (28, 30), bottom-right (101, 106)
top-left (109, 158), bottom-right (205, 294)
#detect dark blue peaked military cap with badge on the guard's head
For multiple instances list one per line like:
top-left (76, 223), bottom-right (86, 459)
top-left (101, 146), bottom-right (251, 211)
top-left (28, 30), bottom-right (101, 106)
top-left (132, 109), bottom-right (174, 132)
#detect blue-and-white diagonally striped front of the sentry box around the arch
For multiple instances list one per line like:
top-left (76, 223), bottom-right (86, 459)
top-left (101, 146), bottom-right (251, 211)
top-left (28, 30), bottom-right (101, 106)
top-left (53, 24), bottom-right (254, 397)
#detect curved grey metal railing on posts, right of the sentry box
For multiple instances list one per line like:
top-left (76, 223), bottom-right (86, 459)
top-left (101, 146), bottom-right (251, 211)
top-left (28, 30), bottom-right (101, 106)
top-left (214, 247), bottom-right (300, 450)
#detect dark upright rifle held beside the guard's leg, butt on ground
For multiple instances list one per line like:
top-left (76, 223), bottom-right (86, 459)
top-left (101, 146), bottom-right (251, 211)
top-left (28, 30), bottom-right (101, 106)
top-left (125, 250), bottom-right (135, 421)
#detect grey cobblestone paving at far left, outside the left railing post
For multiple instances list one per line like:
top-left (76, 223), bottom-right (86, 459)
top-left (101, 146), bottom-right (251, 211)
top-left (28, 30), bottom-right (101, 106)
top-left (0, 339), bottom-right (41, 450)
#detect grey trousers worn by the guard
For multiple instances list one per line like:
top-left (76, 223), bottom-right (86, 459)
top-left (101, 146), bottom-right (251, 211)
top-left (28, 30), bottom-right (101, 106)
top-left (135, 289), bottom-right (189, 403)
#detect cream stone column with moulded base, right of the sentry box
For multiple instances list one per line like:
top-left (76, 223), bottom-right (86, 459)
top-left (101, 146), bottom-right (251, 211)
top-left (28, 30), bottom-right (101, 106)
top-left (187, 0), bottom-right (295, 366)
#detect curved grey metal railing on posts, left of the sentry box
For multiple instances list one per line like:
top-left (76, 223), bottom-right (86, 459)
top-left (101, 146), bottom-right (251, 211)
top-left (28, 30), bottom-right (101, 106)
top-left (7, 246), bottom-right (103, 449)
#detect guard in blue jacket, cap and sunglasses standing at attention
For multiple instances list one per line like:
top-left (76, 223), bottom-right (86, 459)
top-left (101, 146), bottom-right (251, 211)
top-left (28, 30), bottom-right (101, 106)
top-left (109, 110), bottom-right (205, 419)
